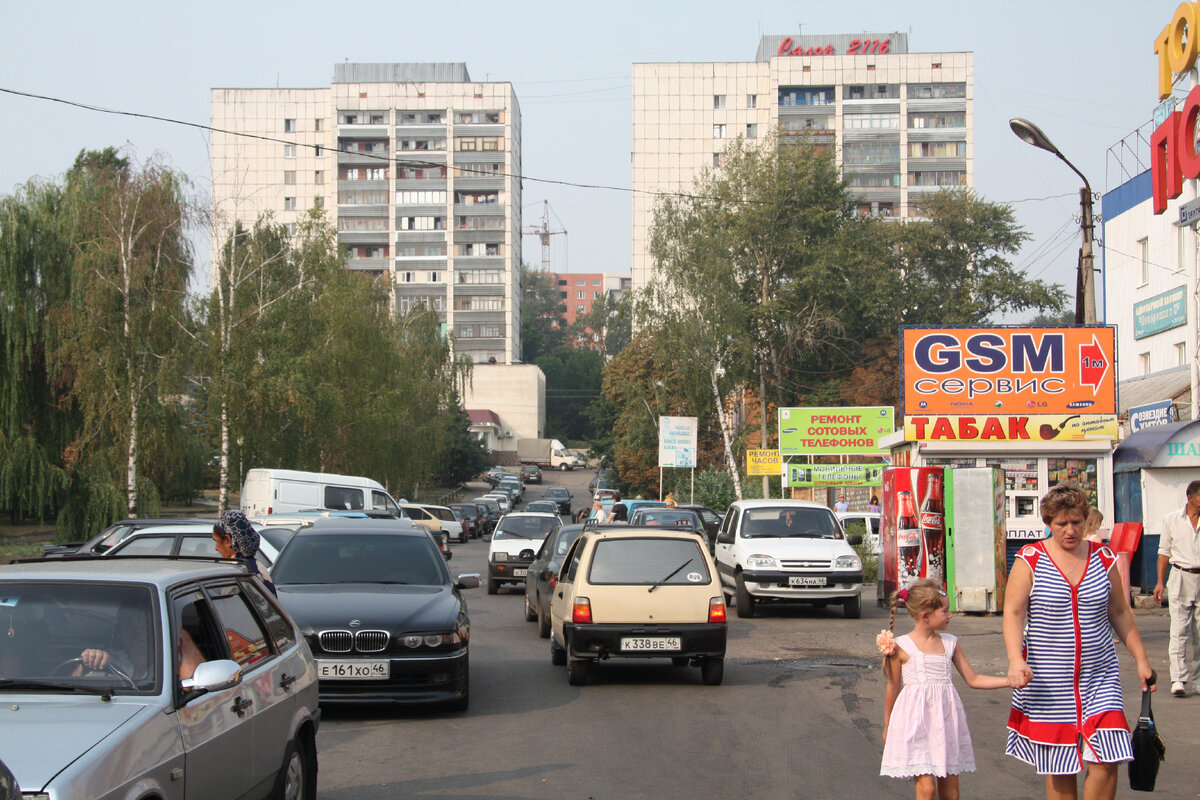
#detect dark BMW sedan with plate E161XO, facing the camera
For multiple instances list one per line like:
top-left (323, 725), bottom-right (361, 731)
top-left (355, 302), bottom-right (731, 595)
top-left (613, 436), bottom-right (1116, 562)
top-left (271, 519), bottom-right (479, 711)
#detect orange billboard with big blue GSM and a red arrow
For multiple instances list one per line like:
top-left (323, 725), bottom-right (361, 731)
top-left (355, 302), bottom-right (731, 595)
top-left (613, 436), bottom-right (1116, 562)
top-left (900, 325), bottom-right (1117, 416)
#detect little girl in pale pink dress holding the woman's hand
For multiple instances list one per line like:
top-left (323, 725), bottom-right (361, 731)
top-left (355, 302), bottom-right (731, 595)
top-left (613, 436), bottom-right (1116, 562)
top-left (876, 579), bottom-right (1009, 800)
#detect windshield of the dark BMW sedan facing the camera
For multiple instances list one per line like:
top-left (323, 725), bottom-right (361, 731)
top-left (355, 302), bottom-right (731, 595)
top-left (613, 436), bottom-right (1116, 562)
top-left (271, 533), bottom-right (449, 587)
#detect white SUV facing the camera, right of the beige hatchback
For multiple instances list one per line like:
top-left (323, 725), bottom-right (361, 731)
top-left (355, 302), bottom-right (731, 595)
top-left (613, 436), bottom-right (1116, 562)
top-left (716, 500), bottom-right (863, 619)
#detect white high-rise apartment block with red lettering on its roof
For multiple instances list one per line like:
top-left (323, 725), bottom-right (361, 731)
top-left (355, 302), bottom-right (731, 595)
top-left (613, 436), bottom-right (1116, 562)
top-left (632, 34), bottom-right (974, 289)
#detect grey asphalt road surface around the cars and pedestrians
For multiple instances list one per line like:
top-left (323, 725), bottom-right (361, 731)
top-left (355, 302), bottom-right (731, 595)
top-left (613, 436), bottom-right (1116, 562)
top-left (318, 470), bottom-right (1200, 800)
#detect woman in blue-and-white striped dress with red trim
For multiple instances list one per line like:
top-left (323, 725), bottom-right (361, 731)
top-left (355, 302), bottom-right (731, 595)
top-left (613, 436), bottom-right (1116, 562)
top-left (1003, 485), bottom-right (1151, 799)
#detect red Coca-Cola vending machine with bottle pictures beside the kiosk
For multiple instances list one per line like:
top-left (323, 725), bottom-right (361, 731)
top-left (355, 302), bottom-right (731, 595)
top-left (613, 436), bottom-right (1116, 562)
top-left (875, 467), bottom-right (947, 604)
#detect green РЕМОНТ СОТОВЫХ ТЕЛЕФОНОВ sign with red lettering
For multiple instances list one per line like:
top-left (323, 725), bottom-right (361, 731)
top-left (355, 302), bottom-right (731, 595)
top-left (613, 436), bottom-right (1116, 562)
top-left (779, 405), bottom-right (895, 457)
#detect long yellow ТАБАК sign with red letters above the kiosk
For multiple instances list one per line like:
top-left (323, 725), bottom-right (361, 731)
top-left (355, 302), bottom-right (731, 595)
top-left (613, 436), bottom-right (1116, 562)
top-left (904, 414), bottom-right (1117, 441)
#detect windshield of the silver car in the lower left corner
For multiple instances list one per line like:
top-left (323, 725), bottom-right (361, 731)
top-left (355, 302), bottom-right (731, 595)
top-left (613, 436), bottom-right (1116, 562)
top-left (0, 581), bottom-right (163, 694)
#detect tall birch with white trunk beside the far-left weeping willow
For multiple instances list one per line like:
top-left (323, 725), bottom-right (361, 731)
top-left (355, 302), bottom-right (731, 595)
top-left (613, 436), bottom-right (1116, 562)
top-left (64, 149), bottom-right (193, 515)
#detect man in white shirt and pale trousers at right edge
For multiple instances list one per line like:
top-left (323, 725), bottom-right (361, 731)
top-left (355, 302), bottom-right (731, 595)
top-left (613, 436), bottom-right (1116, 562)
top-left (1154, 481), bottom-right (1200, 697)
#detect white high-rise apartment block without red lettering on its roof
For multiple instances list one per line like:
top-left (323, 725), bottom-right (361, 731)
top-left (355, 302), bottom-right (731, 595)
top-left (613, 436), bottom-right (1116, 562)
top-left (211, 64), bottom-right (521, 363)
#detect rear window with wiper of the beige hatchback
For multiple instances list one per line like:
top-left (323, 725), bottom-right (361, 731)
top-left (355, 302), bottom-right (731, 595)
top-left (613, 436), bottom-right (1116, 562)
top-left (588, 537), bottom-right (710, 587)
